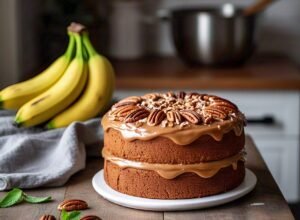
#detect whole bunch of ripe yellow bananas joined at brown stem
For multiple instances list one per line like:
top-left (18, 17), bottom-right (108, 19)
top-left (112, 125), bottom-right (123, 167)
top-left (0, 23), bottom-right (115, 128)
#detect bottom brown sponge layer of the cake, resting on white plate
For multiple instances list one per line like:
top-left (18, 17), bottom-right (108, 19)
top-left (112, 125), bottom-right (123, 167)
top-left (104, 161), bottom-right (245, 199)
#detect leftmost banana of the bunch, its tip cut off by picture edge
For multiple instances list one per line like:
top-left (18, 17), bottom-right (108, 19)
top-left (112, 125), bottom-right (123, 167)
top-left (0, 34), bottom-right (75, 109)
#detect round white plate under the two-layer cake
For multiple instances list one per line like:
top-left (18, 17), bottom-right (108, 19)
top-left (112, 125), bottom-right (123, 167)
top-left (92, 169), bottom-right (257, 211)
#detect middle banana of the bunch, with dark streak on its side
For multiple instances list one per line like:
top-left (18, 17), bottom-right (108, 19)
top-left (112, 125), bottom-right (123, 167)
top-left (15, 33), bottom-right (87, 127)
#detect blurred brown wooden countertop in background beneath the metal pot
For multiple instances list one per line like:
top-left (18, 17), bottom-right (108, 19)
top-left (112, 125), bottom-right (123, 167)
top-left (113, 56), bottom-right (300, 90)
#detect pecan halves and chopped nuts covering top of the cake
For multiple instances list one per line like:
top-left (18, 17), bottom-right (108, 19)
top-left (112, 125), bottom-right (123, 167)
top-left (108, 92), bottom-right (245, 127)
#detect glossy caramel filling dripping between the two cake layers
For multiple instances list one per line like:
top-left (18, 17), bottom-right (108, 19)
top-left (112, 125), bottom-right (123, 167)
top-left (102, 147), bottom-right (246, 179)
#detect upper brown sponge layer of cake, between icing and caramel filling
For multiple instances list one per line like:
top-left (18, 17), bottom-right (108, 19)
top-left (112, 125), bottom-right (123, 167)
top-left (104, 129), bottom-right (245, 164)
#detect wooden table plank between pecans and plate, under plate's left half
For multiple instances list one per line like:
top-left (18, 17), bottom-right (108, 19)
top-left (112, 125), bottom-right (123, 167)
top-left (65, 158), bottom-right (163, 220)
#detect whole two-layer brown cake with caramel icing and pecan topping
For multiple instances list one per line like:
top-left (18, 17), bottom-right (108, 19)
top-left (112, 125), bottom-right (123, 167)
top-left (102, 92), bottom-right (245, 199)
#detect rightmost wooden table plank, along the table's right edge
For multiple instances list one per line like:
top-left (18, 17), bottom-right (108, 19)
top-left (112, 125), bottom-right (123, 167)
top-left (165, 137), bottom-right (294, 220)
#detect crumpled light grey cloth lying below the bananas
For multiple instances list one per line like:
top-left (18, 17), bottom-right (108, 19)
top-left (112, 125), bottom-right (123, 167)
top-left (0, 110), bottom-right (103, 191)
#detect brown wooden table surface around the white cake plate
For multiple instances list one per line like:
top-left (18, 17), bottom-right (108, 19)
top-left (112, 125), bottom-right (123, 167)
top-left (0, 137), bottom-right (293, 220)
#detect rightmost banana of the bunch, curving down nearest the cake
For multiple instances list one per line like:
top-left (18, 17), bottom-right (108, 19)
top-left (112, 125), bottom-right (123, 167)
top-left (47, 32), bottom-right (115, 129)
